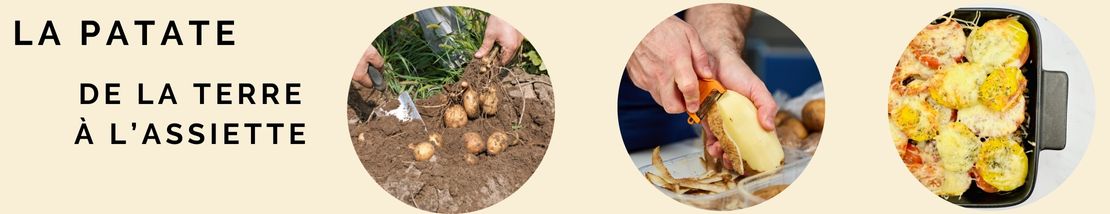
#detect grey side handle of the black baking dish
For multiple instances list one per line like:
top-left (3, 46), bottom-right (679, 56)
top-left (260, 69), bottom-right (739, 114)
top-left (1037, 70), bottom-right (1068, 150)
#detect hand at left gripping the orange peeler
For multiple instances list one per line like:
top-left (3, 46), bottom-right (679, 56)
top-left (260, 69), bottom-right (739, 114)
top-left (626, 17), bottom-right (714, 114)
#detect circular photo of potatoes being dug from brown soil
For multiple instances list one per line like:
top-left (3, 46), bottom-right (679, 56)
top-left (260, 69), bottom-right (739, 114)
top-left (347, 7), bottom-right (555, 213)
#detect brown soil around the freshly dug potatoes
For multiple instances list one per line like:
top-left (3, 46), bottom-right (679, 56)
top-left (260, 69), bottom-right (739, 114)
top-left (347, 57), bottom-right (555, 213)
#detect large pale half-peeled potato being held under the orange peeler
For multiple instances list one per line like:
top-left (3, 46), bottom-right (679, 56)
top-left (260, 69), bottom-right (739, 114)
top-left (706, 91), bottom-right (786, 172)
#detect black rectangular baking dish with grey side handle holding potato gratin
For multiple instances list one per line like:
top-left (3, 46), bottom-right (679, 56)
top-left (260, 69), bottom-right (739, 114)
top-left (932, 8), bottom-right (1068, 207)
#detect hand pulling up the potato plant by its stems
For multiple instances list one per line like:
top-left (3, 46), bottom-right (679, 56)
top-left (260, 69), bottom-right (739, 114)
top-left (474, 14), bottom-right (524, 64)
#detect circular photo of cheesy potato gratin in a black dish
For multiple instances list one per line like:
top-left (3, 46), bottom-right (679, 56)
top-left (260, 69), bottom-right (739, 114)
top-left (887, 8), bottom-right (1094, 207)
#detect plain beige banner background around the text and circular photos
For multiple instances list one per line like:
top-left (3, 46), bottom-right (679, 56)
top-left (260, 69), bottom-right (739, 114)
top-left (0, 1), bottom-right (1110, 213)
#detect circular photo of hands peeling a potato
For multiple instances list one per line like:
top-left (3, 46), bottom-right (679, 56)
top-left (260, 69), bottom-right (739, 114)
top-left (617, 3), bottom-right (825, 211)
